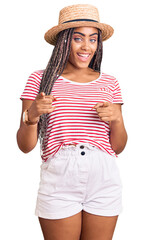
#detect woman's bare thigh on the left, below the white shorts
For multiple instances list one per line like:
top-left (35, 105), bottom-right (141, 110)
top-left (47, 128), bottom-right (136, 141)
top-left (39, 212), bottom-right (82, 240)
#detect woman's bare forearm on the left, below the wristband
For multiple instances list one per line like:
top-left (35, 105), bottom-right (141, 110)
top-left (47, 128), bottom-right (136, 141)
top-left (17, 123), bottom-right (38, 153)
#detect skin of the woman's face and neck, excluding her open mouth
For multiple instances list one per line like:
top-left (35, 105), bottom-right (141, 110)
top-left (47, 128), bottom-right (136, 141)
top-left (62, 27), bottom-right (100, 82)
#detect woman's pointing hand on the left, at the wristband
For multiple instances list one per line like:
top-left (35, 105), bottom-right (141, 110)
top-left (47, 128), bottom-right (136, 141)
top-left (28, 92), bottom-right (57, 122)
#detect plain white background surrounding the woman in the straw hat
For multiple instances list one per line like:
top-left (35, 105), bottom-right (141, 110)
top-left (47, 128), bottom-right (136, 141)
top-left (0, 0), bottom-right (144, 240)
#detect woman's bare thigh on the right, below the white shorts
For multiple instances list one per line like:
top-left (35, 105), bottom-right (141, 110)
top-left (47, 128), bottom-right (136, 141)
top-left (80, 211), bottom-right (118, 240)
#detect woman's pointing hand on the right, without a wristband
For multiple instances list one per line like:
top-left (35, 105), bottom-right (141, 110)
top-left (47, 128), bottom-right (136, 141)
top-left (92, 102), bottom-right (122, 123)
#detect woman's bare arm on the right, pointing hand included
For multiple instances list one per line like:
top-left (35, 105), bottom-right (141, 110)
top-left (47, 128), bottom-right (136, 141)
top-left (93, 102), bottom-right (127, 154)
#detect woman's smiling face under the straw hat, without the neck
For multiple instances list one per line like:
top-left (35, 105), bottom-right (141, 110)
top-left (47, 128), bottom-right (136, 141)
top-left (68, 27), bottom-right (98, 68)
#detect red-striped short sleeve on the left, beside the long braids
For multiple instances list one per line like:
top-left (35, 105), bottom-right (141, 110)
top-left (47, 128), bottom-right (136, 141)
top-left (20, 70), bottom-right (43, 100)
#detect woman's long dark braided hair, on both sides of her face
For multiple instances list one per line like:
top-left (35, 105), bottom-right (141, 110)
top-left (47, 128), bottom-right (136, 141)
top-left (38, 28), bottom-right (103, 150)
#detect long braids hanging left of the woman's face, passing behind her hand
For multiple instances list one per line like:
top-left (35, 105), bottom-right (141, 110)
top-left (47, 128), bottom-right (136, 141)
top-left (38, 28), bottom-right (74, 148)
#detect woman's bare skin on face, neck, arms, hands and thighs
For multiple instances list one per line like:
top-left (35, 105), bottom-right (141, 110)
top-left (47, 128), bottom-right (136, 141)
top-left (17, 27), bottom-right (127, 240)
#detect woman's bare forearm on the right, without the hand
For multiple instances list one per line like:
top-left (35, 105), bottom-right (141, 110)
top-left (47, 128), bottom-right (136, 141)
top-left (110, 117), bottom-right (127, 154)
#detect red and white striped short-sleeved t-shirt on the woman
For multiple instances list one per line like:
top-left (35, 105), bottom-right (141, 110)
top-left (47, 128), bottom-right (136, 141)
top-left (20, 70), bottom-right (123, 161)
